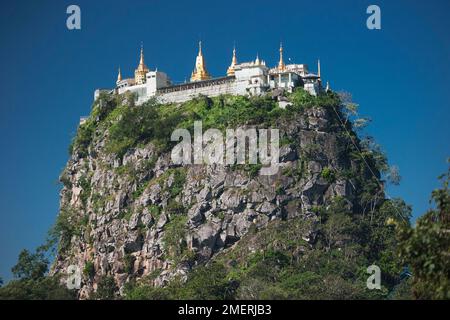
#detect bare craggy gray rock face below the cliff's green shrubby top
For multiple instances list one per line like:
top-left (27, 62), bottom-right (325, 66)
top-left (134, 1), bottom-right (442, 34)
top-left (51, 104), bottom-right (362, 298)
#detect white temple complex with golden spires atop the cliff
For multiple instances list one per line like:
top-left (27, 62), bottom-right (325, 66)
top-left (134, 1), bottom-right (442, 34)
top-left (95, 42), bottom-right (323, 104)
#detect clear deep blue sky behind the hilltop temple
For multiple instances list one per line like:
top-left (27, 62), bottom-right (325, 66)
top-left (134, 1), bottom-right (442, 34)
top-left (0, 0), bottom-right (450, 280)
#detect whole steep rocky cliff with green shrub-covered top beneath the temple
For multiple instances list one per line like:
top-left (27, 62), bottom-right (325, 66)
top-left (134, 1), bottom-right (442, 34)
top-left (52, 92), bottom-right (383, 298)
